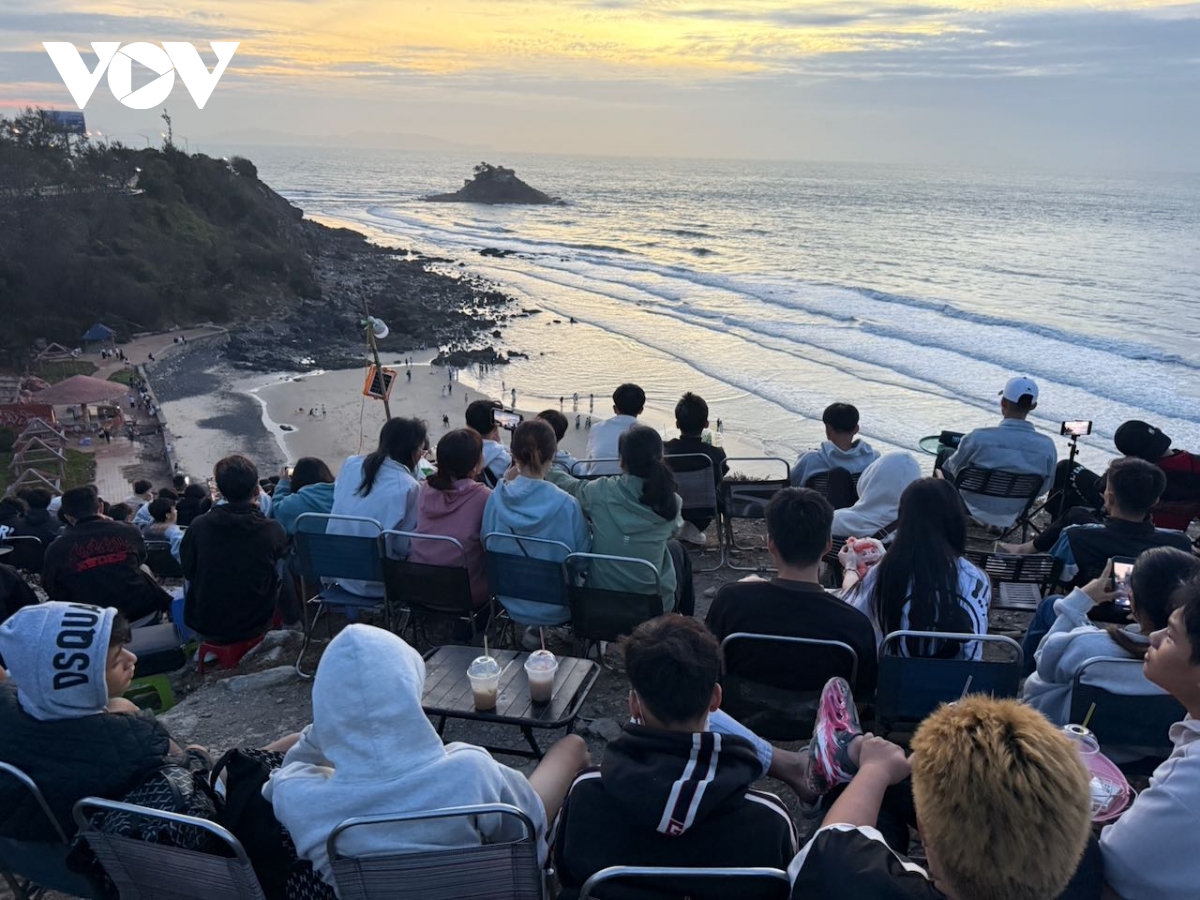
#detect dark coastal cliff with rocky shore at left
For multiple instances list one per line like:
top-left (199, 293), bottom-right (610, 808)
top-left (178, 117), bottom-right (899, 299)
top-left (0, 109), bottom-right (521, 370)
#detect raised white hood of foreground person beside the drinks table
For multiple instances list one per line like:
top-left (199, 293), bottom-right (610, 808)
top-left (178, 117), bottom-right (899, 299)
top-left (312, 624), bottom-right (445, 780)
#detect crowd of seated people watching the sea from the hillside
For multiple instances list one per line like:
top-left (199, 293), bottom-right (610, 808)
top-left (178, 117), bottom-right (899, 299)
top-left (0, 378), bottom-right (1200, 900)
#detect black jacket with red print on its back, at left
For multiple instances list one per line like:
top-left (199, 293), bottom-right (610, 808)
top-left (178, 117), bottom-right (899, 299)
top-left (42, 516), bottom-right (170, 622)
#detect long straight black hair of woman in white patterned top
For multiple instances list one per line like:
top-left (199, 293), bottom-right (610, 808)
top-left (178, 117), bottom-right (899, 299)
top-left (871, 478), bottom-right (974, 650)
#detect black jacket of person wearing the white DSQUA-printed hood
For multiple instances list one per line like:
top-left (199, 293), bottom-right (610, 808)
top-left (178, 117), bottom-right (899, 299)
top-left (0, 682), bottom-right (170, 840)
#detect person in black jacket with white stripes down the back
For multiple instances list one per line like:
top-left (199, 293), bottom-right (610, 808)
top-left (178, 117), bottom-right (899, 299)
top-left (554, 616), bottom-right (797, 900)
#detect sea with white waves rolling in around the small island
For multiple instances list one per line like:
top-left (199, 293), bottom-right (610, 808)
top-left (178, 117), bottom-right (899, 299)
top-left (211, 148), bottom-right (1200, 466)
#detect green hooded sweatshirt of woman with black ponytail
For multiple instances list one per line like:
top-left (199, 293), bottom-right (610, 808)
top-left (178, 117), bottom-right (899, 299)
top-left (546, 467), bottom-right (683, 612)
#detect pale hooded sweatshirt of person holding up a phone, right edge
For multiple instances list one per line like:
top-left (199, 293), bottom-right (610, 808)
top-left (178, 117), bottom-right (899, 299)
top-left (1021, 588), bottom-right (1163, 734)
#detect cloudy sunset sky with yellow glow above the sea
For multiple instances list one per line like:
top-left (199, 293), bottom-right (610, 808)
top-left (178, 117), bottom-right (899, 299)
top-left (0, 0), bottom-right (1200, 172)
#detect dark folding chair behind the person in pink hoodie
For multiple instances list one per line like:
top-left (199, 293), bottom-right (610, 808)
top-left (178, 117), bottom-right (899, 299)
top-left (379, 530), bottom-right (479, 643)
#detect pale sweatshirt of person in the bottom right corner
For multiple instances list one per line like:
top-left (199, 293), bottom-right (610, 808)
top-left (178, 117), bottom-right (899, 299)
top-left (1100, 716), bottom-right (1200, 900)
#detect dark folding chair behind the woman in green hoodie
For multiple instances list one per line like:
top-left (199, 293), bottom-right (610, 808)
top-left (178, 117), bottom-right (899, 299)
top-left (564, 553), bottom-right (662, 658)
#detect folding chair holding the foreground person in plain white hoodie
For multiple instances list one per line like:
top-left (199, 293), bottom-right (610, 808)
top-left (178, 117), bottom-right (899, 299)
top-left (326, 803), bottom-right (545, 900)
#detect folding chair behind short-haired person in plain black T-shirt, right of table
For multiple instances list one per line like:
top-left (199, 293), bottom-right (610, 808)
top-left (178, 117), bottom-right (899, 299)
top-left (721, 631), bottom-right (863, 740)
